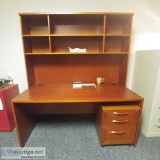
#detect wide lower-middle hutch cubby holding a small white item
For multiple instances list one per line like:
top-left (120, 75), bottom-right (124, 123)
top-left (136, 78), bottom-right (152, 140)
top-left (51, 36), bottom-right (103, 54)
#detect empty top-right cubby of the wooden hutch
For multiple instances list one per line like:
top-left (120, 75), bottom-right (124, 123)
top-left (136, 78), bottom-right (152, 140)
top-left (105, 15), bottom-right (132, 35)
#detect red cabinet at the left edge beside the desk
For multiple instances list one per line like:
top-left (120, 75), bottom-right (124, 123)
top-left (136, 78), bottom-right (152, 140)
top-left (0, 84), bottom-right (19, 132)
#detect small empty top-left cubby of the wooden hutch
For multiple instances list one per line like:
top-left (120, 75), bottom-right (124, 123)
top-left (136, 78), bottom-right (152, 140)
top-left (21, 15), bottom-right (49, 35)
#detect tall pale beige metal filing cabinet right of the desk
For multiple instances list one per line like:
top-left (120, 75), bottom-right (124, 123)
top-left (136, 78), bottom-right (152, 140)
top-left (133, 50), bottom-right (160, 137)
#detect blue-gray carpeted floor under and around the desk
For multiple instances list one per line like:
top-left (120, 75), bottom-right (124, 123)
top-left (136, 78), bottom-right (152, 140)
top-left (0, 116), bottom-right (160, 160)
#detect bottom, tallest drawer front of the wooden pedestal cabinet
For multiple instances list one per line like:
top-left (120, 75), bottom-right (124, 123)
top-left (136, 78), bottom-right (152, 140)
top-left (101, 126), bottom-right (136, 145)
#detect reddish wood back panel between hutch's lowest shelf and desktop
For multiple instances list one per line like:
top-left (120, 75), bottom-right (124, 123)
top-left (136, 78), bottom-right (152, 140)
top-left (31, 55), bottom-right (126, 84)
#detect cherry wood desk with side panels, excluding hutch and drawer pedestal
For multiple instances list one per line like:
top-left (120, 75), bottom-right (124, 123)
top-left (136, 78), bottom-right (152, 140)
top-left (12, 83), bottom-right (143, 147)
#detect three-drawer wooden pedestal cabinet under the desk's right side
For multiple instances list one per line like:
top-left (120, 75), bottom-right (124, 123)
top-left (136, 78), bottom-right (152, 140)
top-left (97, 103), bottom-right (141, 146)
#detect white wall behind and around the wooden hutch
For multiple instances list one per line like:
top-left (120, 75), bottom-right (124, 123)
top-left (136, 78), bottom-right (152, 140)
top-left (0, 0), bottom-right (160, 91)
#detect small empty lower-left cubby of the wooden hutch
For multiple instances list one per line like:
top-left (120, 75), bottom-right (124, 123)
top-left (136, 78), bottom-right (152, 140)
top-left (23, 36), bottom-right (50, 53)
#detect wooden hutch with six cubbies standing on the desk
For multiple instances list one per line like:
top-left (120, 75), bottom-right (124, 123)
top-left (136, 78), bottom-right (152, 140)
top-left (19, 13), bottom-right (133, 86)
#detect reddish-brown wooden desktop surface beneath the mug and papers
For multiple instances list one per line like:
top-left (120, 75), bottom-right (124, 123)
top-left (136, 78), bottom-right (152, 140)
top-left (12, 83), bottom-right (142, 103)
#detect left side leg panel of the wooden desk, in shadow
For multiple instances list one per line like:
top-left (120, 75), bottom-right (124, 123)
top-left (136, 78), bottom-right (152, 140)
top-left (12, 103), bottom-right (36, 147)
